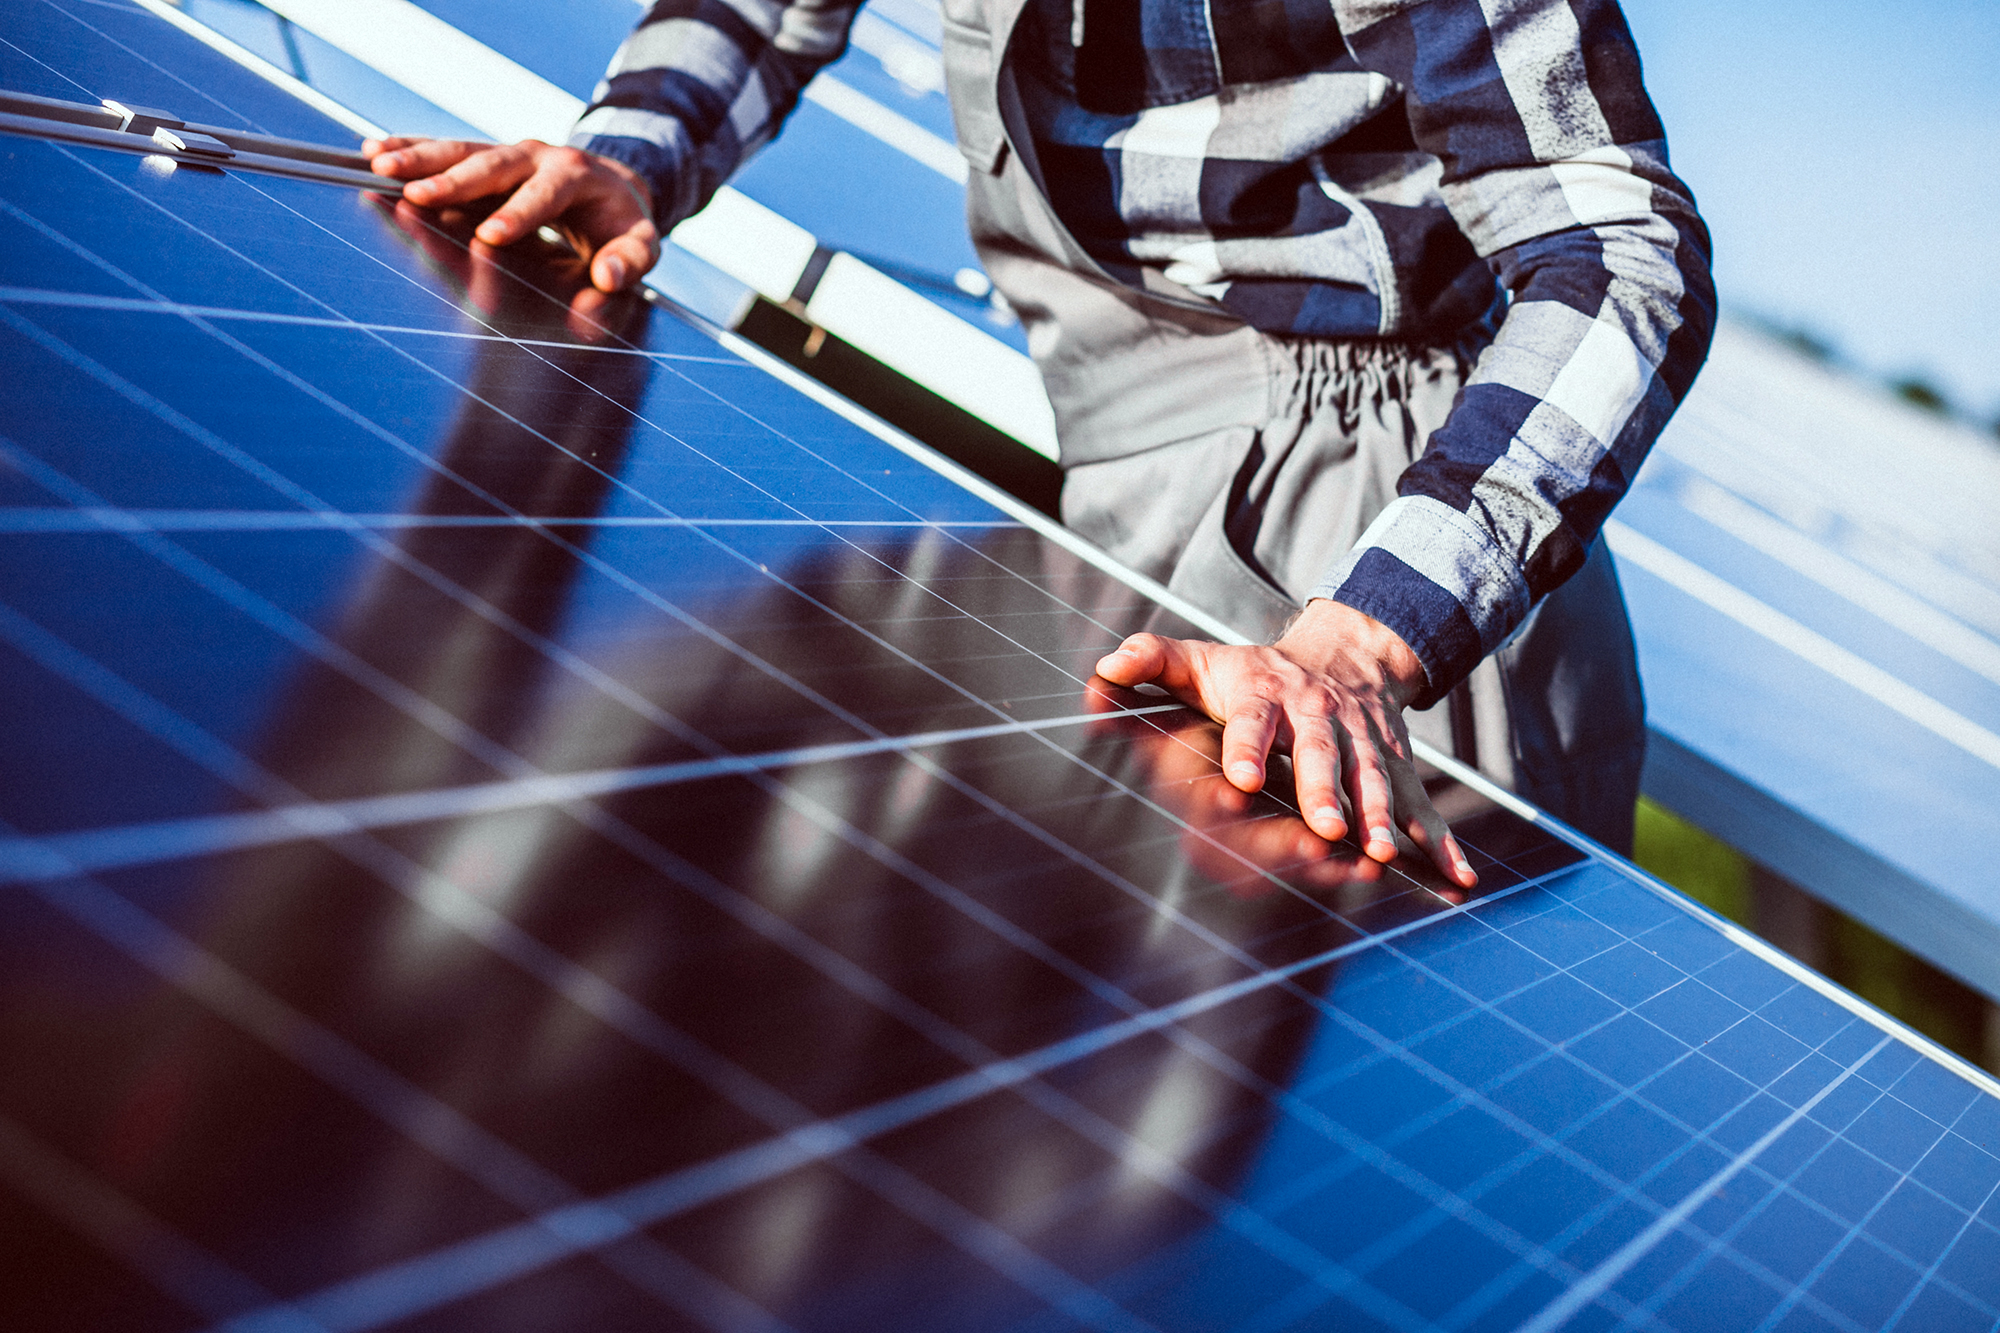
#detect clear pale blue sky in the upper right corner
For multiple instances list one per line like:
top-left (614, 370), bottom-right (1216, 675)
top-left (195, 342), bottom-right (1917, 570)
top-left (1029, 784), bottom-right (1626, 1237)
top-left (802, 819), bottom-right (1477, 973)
top-left (1624, 0), bottom-right (2000, 420)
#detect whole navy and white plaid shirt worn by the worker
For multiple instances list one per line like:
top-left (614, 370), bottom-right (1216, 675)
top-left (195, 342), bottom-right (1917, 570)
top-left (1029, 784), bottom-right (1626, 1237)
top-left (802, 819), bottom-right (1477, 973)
top-left (572, 0), bottom-right (1714, 703)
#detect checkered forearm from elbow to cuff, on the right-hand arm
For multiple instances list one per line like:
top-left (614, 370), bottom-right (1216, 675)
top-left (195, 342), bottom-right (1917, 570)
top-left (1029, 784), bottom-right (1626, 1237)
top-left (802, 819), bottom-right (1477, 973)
top-left (1314, 205), bottom-right (1714, 705)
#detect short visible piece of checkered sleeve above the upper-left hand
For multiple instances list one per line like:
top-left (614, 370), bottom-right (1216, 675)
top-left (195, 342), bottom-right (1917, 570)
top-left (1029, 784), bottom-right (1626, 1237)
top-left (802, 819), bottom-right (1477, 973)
top-left (570, 0), bottom-right (860, 228)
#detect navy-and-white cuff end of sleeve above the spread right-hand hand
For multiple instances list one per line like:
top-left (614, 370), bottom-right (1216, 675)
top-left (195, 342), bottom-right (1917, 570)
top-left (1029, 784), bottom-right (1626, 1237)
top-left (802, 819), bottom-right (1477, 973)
top-left (1308, 494), bottom-right (1532, 709)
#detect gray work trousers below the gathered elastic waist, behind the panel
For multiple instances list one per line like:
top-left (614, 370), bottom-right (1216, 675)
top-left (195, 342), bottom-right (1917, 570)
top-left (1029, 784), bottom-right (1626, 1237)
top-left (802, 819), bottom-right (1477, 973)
top-left (1062, 338), bottom-right (1646, 853)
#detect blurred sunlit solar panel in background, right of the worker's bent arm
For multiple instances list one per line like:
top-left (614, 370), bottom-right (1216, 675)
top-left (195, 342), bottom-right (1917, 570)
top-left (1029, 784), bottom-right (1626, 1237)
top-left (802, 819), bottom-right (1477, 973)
top-left (1610, 326), bottom-right (2000, 997)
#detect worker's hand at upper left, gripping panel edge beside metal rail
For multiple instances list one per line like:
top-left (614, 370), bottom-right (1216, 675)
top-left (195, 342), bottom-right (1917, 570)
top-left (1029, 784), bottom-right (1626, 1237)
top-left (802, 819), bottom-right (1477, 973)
top-left (362, 138), bottom-right (660, 292)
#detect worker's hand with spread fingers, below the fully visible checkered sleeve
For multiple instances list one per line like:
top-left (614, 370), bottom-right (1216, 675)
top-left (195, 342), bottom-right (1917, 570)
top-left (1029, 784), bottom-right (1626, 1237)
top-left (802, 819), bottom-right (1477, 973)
top-left (1098, 600), bottom-right (1478, 889)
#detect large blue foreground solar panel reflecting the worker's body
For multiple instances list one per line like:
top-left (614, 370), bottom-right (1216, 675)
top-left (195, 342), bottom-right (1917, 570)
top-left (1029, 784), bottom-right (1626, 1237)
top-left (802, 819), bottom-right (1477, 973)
top-left (0, 2), bottom-right (2000, 1331)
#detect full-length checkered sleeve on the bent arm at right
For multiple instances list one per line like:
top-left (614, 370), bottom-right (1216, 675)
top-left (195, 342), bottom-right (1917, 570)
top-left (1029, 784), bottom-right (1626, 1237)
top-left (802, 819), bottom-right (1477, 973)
top-left (1312, 0), bottom-right (1716, 707)
